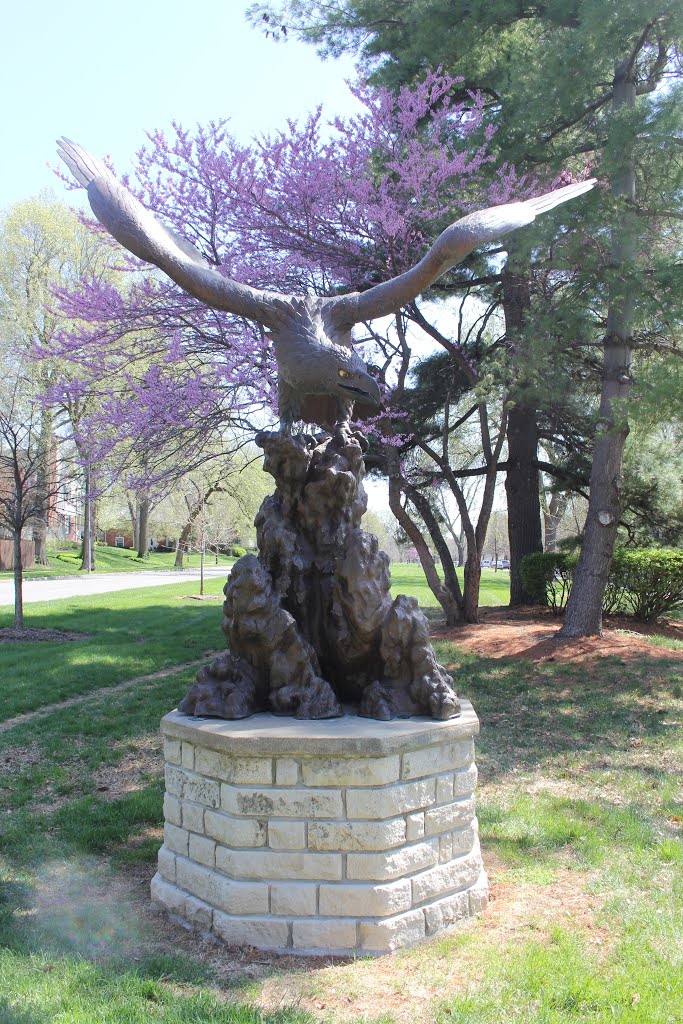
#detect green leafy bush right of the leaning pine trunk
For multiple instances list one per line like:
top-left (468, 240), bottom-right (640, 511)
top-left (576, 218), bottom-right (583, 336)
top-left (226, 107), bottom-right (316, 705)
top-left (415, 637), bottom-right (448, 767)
top-left (612, 548), bottom-right (683, 623)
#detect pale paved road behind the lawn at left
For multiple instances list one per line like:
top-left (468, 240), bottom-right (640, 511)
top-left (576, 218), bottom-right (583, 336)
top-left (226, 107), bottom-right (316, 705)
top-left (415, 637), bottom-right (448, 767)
top-left (0, 565), bottom-right (229, 605)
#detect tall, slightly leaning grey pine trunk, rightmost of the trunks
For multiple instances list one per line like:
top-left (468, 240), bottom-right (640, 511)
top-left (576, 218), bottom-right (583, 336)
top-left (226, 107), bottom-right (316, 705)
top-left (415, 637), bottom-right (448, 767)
top-left (560, 60), bottom-right (638, 637)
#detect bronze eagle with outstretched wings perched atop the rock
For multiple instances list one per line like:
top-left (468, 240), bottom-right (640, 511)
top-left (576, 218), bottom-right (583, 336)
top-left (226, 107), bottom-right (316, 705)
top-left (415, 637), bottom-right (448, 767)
top-left (57, 138), bottom-right (595, 433)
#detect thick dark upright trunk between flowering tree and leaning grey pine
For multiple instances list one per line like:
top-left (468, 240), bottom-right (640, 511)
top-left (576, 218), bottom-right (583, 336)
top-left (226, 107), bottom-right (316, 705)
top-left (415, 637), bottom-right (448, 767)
top-left (503, 266), bottom-right (543, 607)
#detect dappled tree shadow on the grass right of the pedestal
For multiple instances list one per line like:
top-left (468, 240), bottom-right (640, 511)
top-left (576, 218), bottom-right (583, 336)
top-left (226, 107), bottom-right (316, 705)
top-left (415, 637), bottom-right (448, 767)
top-left (436, 643), bottom-right (683, 780)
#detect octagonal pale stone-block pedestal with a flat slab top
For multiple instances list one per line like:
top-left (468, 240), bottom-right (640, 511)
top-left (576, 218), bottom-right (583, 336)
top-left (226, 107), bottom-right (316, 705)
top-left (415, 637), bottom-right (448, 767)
top-left (152, 701), bottom-right (487, 955)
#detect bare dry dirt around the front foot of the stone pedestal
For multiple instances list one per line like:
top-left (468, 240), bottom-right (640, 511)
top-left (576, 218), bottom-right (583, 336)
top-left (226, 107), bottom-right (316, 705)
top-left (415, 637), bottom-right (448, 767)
top-left (98, 856), bottom-right (609, 1024)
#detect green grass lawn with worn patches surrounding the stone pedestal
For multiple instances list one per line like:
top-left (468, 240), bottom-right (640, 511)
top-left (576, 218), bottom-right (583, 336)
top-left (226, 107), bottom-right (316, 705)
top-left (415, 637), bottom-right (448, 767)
top-left (0, 566), bottom-right (683, 1024)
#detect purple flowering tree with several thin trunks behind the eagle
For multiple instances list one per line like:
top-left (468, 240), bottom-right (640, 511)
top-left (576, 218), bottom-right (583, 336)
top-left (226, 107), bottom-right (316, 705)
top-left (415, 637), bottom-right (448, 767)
top-left (50, 72), bottom-right (544, 623)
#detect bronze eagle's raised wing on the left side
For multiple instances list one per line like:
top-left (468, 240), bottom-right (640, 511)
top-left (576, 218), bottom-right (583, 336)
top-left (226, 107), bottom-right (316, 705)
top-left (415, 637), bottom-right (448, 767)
top-left (57, 138), bottom-right (276, 326)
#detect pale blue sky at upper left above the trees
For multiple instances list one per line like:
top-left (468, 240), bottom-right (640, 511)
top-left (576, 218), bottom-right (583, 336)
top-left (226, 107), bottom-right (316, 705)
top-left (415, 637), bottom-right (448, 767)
top-left (0, 0), bottom-right (360, 207)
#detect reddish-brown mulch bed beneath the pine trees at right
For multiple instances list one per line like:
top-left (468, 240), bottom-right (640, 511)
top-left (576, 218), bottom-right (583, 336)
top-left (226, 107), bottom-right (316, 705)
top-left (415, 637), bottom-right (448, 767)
top-left (433, 608), bottom-right (683, 663)
